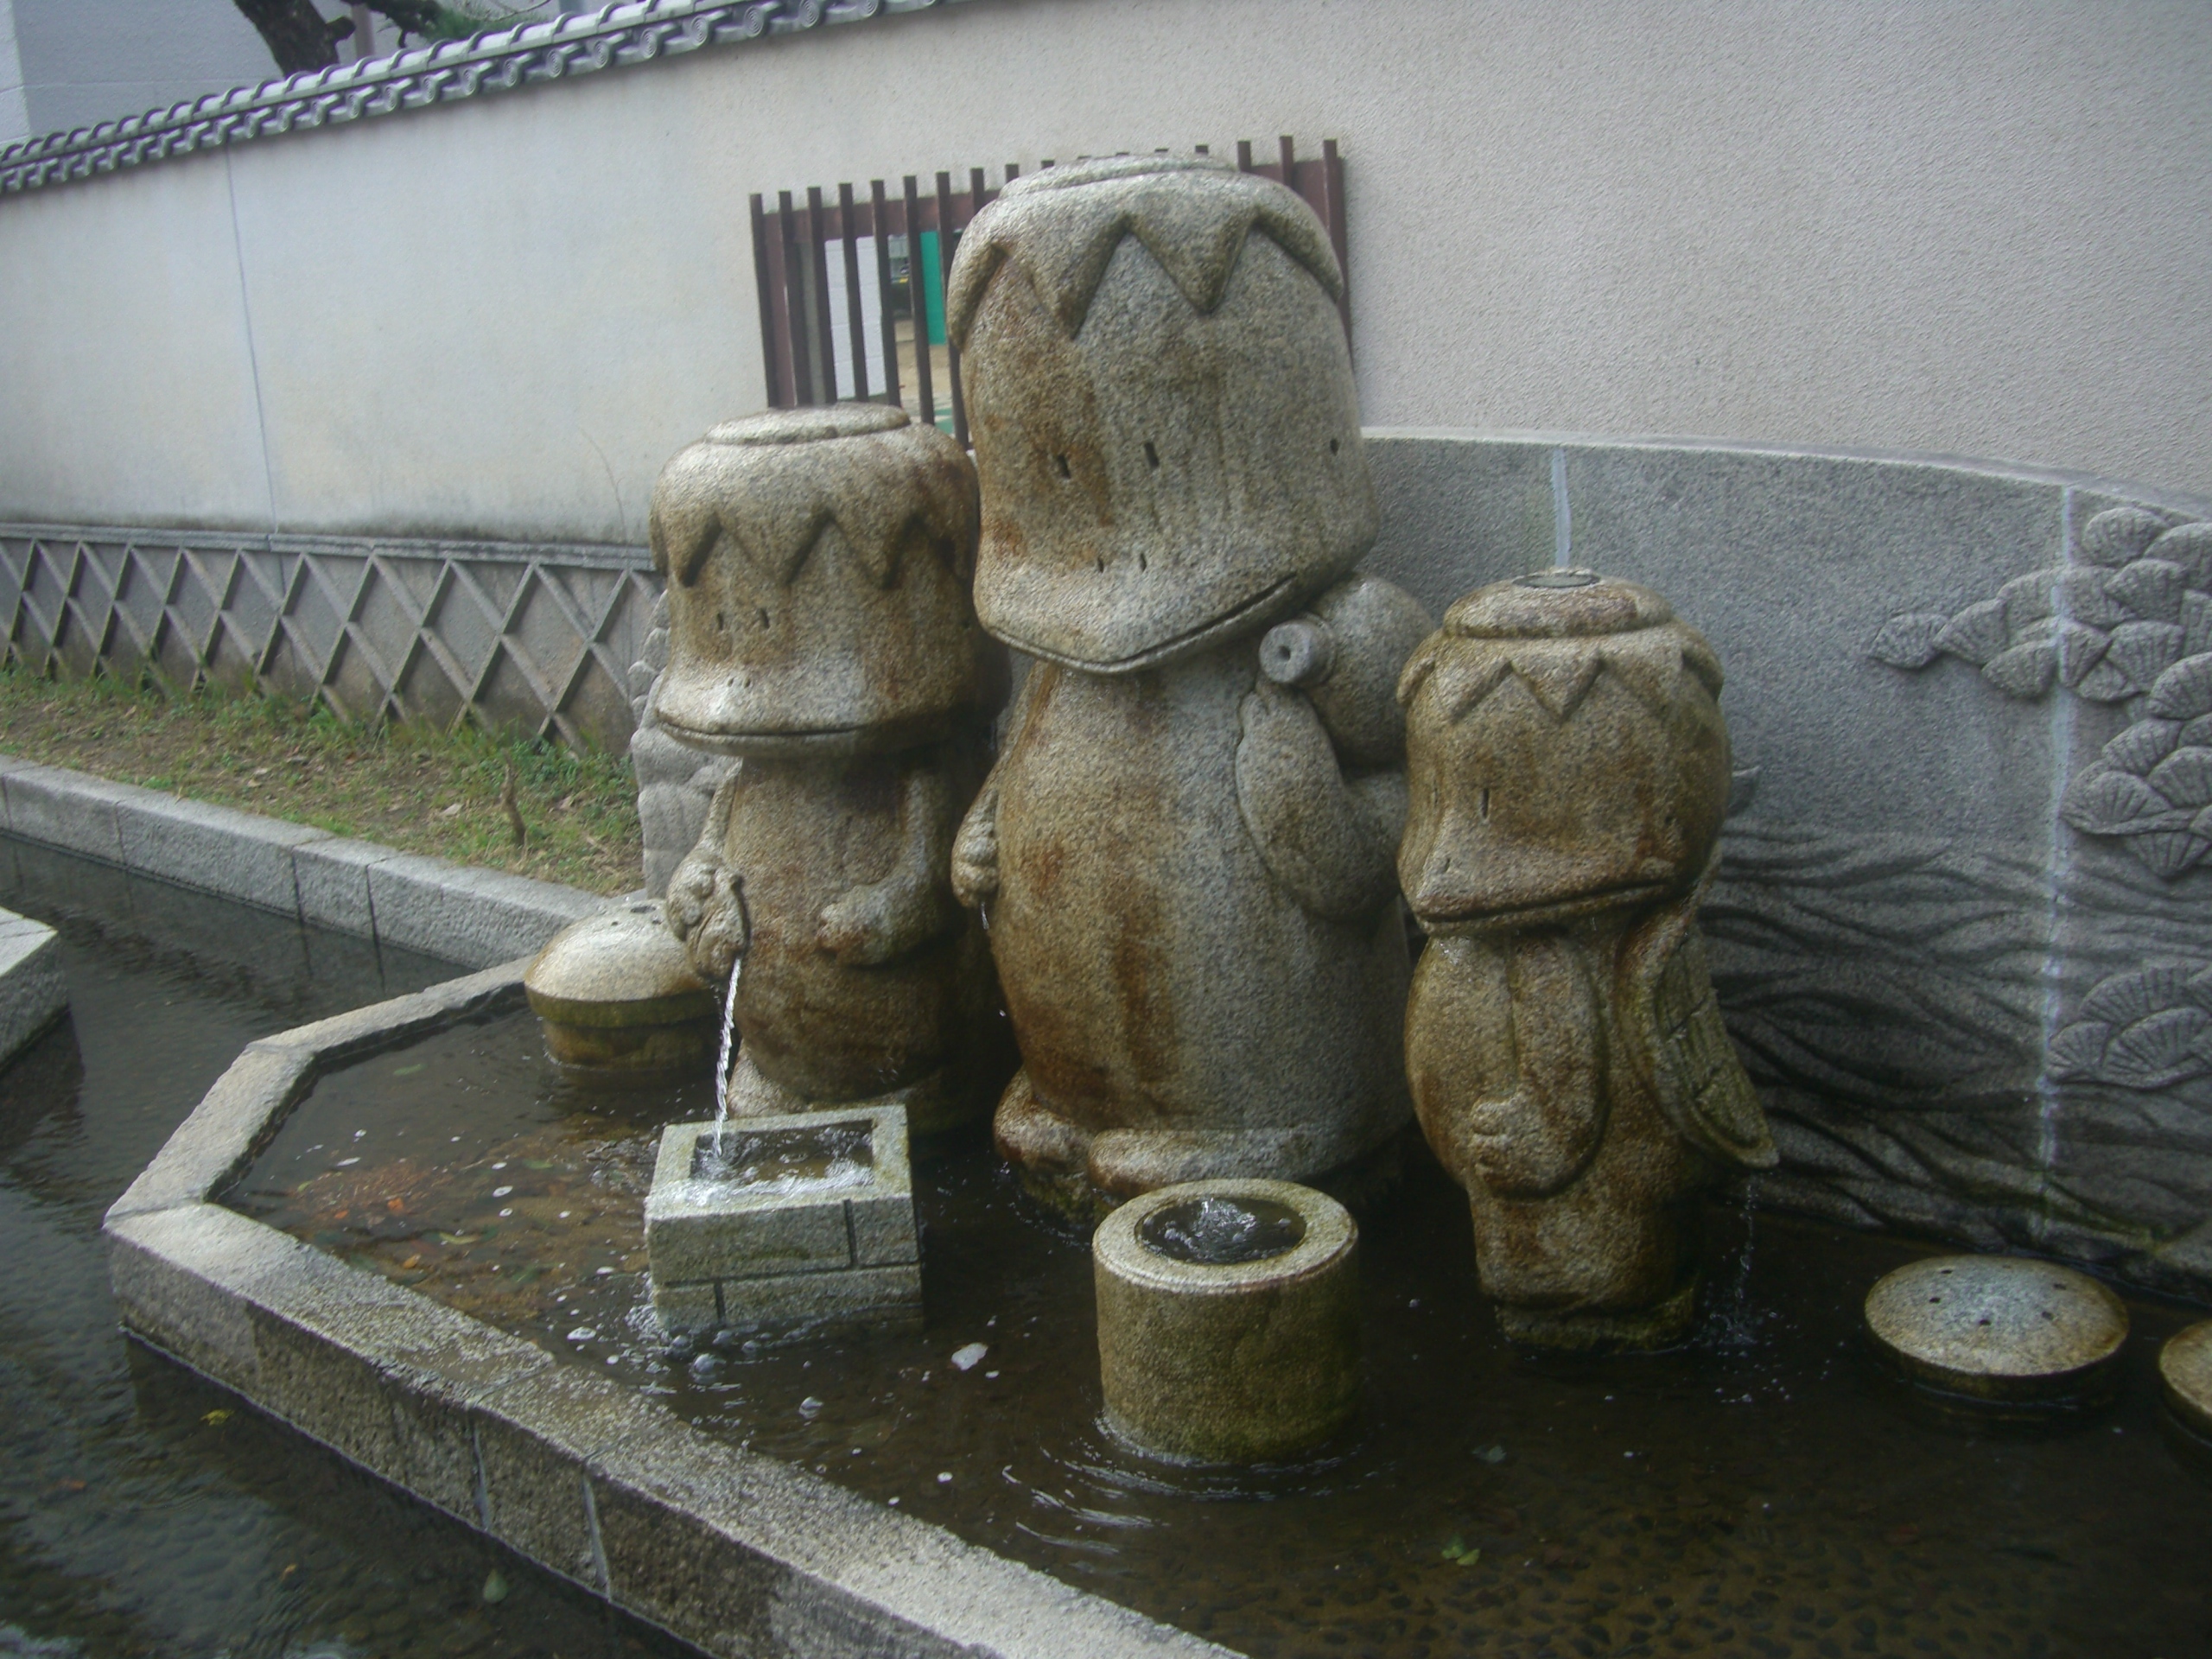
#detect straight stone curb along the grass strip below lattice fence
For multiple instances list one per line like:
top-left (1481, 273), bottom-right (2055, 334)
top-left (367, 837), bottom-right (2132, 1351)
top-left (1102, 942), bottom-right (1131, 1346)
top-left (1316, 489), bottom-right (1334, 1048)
top-left (0, 754), bottom-right (608, 969)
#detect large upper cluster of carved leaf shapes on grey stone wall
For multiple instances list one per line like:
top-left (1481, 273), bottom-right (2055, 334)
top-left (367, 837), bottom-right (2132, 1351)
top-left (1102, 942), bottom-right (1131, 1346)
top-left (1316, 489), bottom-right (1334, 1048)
top-left (1869, 506), bottom-right (2212, 876)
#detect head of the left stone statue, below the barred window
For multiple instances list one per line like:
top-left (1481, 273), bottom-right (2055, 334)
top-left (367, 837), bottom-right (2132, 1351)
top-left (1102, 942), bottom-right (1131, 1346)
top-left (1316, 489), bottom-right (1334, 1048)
top-left (651, 403), bottom-right (1000, 759)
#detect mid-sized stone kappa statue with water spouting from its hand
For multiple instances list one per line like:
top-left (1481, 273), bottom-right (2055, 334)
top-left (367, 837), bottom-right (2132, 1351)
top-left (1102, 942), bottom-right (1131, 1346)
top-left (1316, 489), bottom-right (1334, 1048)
top-left (651, 403), bottom-right (1011, 1133)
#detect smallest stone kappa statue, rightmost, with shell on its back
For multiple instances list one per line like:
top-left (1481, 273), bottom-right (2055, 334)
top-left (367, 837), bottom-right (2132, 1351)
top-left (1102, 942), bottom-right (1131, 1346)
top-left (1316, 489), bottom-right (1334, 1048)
top-left (1398, 570), bottom-right (1774, 1347)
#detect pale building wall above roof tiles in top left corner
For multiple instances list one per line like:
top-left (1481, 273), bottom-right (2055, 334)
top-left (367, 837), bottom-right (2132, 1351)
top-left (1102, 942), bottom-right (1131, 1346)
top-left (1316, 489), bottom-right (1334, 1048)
top-left (11, 0), bottom-right (276, 137)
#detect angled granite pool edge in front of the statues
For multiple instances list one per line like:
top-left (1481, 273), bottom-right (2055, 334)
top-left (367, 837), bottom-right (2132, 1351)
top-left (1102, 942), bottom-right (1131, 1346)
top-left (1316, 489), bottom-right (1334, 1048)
top-left (104, 963), bottom-right (1228, 1659)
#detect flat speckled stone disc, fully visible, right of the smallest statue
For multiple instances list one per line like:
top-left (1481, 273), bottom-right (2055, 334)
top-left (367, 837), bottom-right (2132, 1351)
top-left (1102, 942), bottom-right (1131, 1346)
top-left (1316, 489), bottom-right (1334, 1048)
top-left (1867, 1256), bottom-right (2128, 1405)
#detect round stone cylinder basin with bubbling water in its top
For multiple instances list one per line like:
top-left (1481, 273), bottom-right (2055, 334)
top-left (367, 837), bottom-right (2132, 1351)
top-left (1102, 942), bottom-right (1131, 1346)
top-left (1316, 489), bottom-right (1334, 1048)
top-left (1090, 1181), bottom-right (1360, 1462)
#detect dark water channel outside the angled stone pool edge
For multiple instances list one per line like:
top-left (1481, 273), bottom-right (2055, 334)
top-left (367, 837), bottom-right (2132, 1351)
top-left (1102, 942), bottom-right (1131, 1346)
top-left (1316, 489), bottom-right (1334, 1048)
top-left (0, 838), bottom-right (690, 1659)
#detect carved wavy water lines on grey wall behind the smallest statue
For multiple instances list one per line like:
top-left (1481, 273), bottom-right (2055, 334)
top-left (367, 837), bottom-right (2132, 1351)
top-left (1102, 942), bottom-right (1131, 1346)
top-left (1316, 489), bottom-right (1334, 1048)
top-left (1703, 821), bottom-right (2212, 1285)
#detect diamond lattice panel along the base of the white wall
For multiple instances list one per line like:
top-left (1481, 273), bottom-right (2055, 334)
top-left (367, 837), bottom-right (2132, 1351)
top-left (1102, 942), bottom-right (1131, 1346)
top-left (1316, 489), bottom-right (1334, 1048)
top-left (0, 524), bottom-right (659, 750)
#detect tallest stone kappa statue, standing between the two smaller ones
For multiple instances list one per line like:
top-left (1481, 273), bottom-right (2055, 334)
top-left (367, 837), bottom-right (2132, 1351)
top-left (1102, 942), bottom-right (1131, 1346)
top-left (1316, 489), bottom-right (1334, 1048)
top-left (949, 157), bottom-right (1429, 1208)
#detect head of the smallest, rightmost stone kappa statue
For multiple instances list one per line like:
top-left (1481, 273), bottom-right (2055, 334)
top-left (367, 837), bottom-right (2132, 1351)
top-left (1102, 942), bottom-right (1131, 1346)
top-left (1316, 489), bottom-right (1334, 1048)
top-left (1398, 570), bottom-right (1730, 931)
